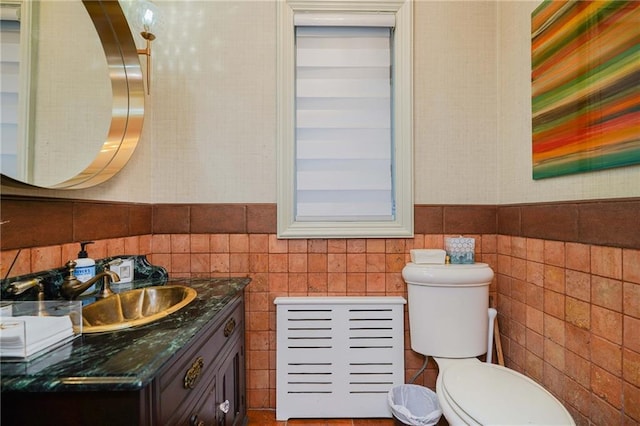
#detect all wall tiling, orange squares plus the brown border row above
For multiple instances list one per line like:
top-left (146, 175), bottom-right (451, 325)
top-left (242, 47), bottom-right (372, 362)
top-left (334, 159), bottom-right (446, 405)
top-left (0, 196), bottom-right (640, 425)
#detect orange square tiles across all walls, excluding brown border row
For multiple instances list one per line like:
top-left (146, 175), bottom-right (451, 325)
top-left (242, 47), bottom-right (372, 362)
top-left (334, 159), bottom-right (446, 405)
top-left (1, 234), bottom-right (640, 425)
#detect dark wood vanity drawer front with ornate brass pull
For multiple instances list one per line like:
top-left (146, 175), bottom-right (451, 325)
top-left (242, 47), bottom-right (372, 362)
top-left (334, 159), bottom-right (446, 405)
top-left (157, 299), bottom-right (244, 424)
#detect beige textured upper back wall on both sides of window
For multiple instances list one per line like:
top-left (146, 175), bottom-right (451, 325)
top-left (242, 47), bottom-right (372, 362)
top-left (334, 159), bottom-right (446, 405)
top-left (152, 1), bottom-right (497, 203)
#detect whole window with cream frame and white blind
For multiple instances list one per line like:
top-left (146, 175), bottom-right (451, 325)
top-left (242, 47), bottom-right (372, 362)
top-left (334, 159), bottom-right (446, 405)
top-left (278, 1), bottom-right (413, 238)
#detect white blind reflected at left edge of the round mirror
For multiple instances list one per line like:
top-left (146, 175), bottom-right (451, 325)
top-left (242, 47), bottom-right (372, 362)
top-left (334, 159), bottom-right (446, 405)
top-left (0, 6), bottom-right (20, 176)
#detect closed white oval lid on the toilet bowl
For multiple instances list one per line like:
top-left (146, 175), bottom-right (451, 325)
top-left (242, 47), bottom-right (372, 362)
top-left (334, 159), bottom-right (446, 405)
top-left (442, 362), bottom-right (575, 425)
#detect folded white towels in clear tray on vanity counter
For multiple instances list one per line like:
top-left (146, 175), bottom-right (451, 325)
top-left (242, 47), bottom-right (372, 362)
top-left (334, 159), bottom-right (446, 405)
top-left (0, 315), bottom-right (73, 358)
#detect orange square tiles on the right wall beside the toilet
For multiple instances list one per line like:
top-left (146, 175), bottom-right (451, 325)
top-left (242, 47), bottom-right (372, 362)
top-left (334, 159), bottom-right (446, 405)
top-left (497, 236), bottom-right (640, 425)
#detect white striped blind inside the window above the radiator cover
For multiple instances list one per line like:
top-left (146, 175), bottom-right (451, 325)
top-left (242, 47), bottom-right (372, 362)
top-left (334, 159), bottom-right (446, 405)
top-left (295, 20), bottom-right (395, 221)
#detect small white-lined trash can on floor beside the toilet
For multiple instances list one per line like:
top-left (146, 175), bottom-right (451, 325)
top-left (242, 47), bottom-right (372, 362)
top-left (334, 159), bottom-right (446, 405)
top-left (387, 384), bottom-right (442, 426)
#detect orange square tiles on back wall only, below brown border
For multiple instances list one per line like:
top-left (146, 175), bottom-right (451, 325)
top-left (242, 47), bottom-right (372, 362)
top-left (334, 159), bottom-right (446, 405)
top-left (144, 234), bottom-right (497, 408)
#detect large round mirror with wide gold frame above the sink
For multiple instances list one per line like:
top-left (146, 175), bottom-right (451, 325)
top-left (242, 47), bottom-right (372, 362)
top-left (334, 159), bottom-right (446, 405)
top-left (2, 0), bottom-right (144, 189)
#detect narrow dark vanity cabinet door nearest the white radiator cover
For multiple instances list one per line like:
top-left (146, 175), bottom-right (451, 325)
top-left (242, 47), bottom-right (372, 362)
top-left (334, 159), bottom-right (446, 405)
top-left (216, 334), bottom-right (246, 426)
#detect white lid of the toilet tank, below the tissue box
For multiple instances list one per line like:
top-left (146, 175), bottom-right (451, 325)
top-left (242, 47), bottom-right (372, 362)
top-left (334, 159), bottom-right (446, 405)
top-left (402, 262), bottom-right (493, 286)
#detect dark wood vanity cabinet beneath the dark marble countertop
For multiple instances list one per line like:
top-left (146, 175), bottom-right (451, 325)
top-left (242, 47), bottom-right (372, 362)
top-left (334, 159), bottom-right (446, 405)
top-left (0, 294), bottom-right (246, 426)
